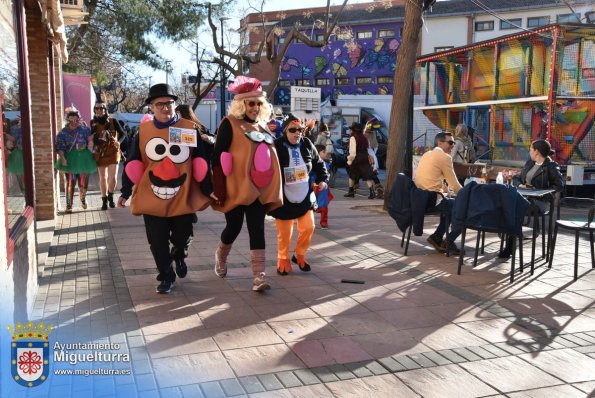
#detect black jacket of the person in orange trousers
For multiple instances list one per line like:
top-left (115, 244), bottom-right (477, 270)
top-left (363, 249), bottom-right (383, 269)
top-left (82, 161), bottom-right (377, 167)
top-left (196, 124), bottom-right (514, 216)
top-left (270, 135), bottom-right (328, 220)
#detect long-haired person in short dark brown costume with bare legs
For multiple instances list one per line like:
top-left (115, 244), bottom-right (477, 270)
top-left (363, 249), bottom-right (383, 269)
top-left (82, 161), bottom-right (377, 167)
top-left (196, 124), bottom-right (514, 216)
top-left (91, 101), bottom-right (126, 210)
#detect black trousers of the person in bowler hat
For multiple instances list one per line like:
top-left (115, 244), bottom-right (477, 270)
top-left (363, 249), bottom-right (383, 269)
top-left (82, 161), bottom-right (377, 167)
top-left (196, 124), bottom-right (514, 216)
top-left (143, 213), bottom-right (193, 282)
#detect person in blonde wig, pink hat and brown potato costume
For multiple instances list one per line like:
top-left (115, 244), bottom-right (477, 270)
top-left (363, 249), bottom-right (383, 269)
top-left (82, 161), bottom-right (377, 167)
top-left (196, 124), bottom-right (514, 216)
top-left (211, 76), bottom-right (283, 292)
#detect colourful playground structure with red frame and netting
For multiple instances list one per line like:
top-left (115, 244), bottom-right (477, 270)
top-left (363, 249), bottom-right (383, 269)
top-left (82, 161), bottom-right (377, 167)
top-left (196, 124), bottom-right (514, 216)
top-left (413, 24), bottom-right (595, 183)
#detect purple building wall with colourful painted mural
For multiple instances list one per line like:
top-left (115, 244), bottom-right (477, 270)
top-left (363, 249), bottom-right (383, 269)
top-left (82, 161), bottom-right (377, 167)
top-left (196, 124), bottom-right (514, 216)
top-left (275, 24), bottom-right (402, 105)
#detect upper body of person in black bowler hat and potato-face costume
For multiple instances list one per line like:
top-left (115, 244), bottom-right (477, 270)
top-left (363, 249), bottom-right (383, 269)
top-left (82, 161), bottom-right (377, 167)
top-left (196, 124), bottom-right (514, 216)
top-left (126, 84), bottom-right (210, 217)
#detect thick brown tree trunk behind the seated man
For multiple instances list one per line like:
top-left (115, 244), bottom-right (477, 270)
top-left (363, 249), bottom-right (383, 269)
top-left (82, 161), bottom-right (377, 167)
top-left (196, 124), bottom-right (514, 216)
top-left (384, 0), bottom-right (423, 208)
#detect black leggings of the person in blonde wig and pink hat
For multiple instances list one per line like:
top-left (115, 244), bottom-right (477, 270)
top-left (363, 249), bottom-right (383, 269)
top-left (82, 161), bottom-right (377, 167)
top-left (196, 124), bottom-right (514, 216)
top-left (221, 199), bottom-right (266, 250)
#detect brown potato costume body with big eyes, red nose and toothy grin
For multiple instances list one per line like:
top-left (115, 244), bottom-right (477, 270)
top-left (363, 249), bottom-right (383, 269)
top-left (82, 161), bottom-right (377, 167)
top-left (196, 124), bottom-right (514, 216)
top-left (126, 119), bottom-right (210, 217)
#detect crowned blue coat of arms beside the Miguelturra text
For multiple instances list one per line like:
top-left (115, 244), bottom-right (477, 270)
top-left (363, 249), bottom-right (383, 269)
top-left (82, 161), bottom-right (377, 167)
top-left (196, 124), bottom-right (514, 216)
top-left (8, 321), bottom-right (52, 387)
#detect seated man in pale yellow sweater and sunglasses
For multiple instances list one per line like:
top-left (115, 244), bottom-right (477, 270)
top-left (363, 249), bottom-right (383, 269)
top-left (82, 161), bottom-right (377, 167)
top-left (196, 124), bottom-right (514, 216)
top-left (414, 132), bottom-right (463, 256)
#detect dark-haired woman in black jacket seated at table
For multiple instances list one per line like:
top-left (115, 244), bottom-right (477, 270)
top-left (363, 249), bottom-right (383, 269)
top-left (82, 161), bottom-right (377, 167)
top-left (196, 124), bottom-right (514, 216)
top-left (498, 139), bottom-right (564, 258)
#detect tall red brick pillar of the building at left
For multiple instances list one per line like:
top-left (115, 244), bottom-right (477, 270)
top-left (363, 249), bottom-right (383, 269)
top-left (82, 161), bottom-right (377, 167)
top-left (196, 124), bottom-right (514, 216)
top-left (26, 7), bottom-right (56, 220)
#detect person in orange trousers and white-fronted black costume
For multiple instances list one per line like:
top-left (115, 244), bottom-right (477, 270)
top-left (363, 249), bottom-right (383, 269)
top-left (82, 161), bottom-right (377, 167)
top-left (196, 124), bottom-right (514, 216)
top-left (270, 113), bottom-right (328, 275)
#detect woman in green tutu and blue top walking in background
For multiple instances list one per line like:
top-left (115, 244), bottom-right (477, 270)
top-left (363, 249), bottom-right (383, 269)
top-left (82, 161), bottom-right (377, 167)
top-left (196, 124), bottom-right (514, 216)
top-left (54, 109), bottom-right (97, 213)
